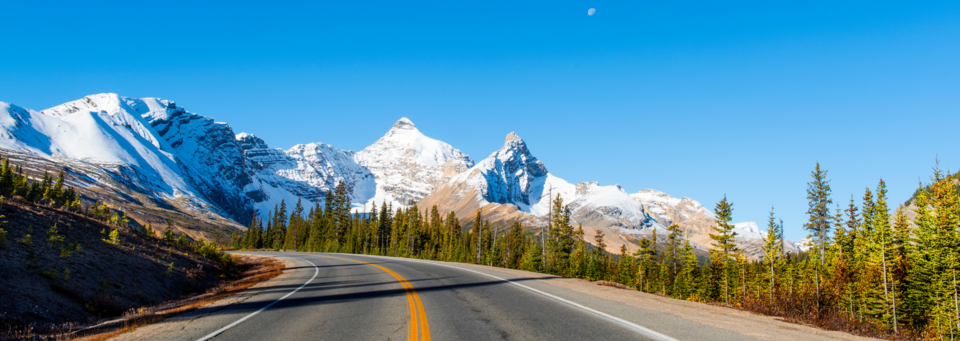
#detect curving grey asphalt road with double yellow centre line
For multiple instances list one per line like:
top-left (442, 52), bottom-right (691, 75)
top-left (139, 252), bottom-right (751, 341)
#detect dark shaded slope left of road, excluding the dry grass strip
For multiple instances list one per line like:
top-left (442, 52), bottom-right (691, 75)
top-left (0, 199), bottom-right (232, 331)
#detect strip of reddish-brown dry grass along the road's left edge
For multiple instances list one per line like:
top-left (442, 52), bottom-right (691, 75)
top-left (54, 255), bottom-right (285, 341)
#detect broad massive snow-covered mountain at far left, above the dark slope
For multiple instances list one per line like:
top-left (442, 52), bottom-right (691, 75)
top-left (0, 94), bottom-right (251, 223)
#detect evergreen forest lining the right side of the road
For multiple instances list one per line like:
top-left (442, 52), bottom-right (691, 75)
top-left (232, 164), bottom-right (960, 340)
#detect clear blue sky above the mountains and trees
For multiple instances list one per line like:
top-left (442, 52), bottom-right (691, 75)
top-left (0, 1), bottom-right (960, 239)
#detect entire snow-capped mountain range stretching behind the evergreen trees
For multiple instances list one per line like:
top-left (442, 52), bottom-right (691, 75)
top-left (0, 94), bottom-right (788, 252)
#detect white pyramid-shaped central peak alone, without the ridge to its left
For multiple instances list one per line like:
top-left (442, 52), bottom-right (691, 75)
top-left (354, 117), bottom-right (473, 207)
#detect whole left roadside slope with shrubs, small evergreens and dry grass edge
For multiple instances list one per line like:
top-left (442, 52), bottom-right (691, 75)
top-left (0, 156), bottom-right (283, 340)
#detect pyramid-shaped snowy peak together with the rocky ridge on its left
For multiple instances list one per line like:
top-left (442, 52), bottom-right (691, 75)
top-left (236, 117), bottom-right (473, 218)
